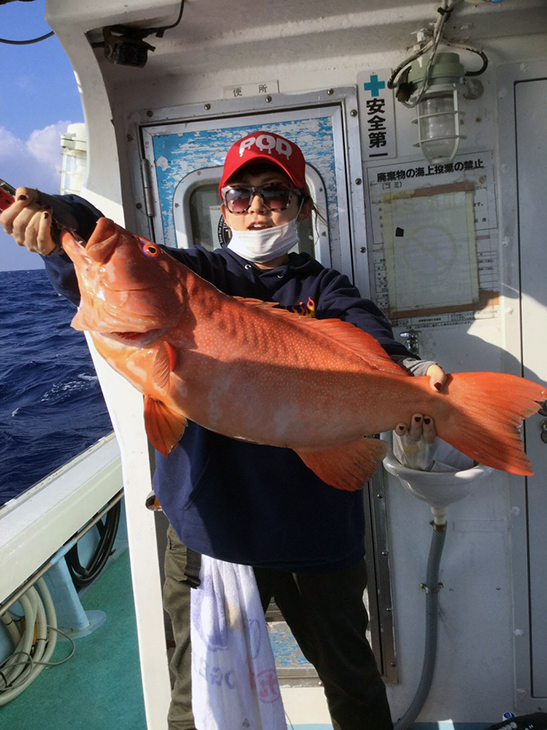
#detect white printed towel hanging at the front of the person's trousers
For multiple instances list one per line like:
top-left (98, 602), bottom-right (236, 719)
top-left (191, 555), bottom-right (287, 730)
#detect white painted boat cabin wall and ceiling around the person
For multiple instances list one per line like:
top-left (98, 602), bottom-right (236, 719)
top-left (48, 0), bottom-right (547, 723)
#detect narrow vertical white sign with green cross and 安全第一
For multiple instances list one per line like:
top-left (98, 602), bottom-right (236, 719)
top-left (357, 69), bottom-right (397, 160)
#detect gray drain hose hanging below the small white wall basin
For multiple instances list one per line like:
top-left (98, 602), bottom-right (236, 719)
top-left (394, 523), bottom-right (446, 730)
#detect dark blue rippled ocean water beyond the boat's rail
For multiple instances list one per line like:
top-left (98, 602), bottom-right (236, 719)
top-left (0, 270), bottom-right (112, 505)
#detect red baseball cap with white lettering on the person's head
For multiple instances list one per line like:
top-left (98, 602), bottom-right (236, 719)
top-left (218, 130), bottom-right (309, 195)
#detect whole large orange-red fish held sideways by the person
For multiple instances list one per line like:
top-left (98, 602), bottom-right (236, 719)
top-left (63, 218), bottom-right (547, 489)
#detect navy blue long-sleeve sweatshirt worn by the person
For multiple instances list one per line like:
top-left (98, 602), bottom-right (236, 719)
top-left (44, 196), bottom-right (411, 572)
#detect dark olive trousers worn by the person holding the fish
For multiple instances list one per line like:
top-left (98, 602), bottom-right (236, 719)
top-left (164, 527), bottom-right (393, 730)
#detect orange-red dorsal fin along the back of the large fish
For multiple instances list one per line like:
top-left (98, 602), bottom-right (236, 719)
top-left (233, 297), bottom-right (406, 375)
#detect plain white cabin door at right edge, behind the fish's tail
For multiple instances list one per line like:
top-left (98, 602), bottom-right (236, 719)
top-left (514, 69), bottom-right (547, 710)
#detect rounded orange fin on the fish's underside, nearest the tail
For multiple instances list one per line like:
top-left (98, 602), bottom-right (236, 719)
top-left (295, 438), bottom-right (387, 492)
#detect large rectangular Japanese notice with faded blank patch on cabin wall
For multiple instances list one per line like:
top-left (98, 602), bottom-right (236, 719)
top-left (367, 151), bottom-right (499, 327)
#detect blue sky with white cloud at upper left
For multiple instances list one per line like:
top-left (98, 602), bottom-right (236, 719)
top-left (0, 0), bottom-right (84, 271)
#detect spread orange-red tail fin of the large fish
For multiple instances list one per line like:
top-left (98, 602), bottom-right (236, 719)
top-left (431, 372), bottom-right (547, 476)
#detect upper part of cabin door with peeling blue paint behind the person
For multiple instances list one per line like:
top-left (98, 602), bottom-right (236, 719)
top-left (133, 87), bottom-right (369, 295)
